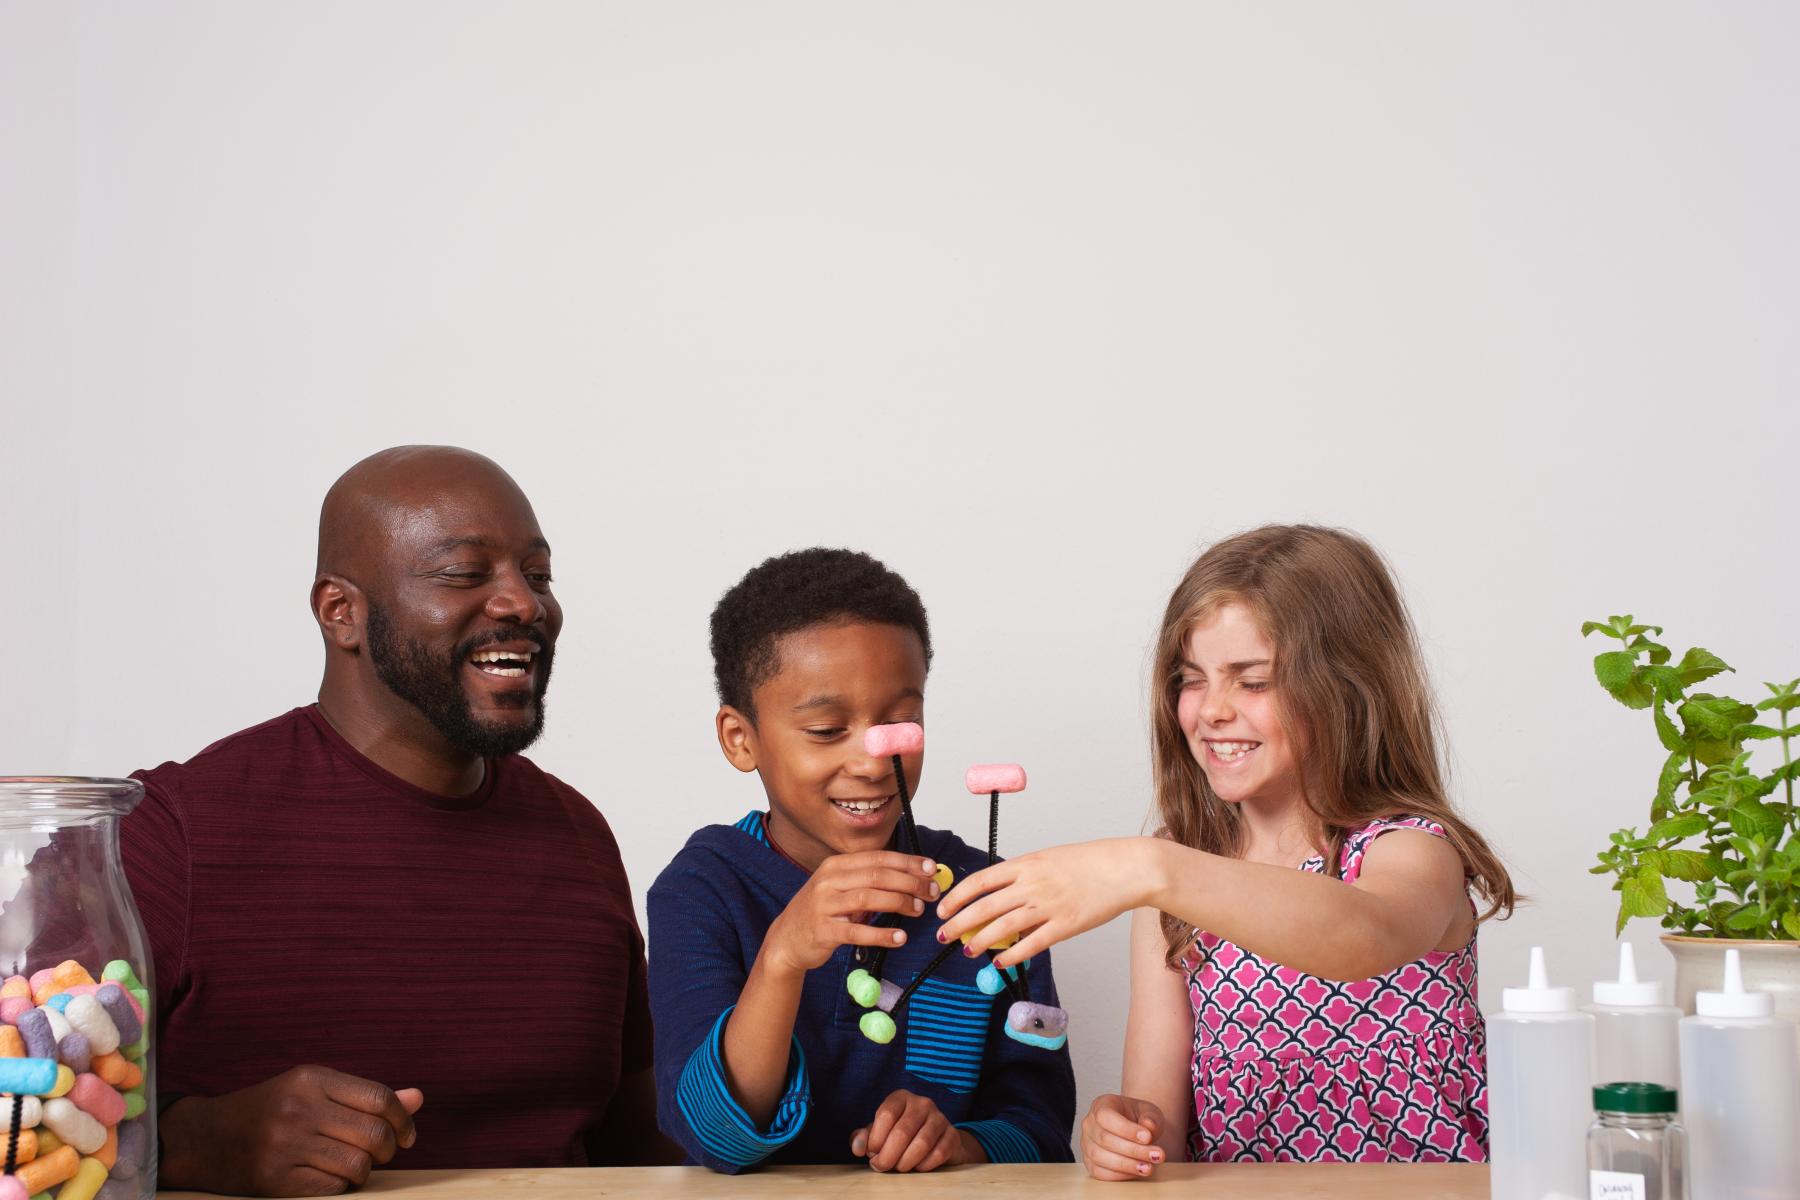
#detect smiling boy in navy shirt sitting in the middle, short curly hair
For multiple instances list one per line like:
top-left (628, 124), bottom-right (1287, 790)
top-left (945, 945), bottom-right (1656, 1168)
top-left (648, 549), bottom-right (1075, 1173)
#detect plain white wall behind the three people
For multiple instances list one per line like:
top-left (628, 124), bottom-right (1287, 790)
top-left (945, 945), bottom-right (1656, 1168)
top-left (0, 0), bottom-right (1800, 1151)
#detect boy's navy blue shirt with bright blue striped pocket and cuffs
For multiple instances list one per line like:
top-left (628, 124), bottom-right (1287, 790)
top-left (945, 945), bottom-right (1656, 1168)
top-left (650, 811), bottom-right (1075, 1173)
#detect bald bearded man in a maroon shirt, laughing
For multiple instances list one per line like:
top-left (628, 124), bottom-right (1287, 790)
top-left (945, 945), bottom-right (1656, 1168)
top-left (122, 446), bottom-right (680, 1196)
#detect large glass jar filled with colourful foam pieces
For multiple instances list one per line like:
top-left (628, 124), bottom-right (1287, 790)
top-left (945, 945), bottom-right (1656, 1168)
top-left (0, 775), bottom-right (157, 1200)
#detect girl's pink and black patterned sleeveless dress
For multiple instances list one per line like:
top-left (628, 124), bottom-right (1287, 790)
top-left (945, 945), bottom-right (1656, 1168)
top-left (1184, 817), bottom-right (1487, 1162)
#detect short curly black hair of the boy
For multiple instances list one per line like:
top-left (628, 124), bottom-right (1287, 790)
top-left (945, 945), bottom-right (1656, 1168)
top-left (713, 547), bottom-right (931, 721)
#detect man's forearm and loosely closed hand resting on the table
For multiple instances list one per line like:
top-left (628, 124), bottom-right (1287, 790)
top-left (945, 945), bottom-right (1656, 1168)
top-left (158, 1067), bottom-right (425, 1196)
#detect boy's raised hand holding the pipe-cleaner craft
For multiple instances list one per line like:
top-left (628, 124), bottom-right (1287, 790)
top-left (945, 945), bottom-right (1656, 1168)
top-left (761, 849), bottom-right (938, 973)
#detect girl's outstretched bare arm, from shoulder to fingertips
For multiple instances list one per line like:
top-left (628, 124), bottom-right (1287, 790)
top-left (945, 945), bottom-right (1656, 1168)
top-left (938, 829), bottom-right (1474, 979)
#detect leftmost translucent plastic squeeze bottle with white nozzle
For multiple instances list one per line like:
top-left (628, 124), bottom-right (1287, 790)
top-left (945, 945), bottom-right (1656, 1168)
top-left (1487, 946), bottom-right (1593, 1200)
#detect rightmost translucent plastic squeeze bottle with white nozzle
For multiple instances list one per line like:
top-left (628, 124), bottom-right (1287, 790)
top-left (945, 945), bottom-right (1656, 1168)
top-left (1681, 950), bottom-right (1800, 1200)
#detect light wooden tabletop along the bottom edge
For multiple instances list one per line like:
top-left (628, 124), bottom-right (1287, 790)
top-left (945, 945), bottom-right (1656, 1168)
top-left (160, 1162), bottom-right (1489, 1200)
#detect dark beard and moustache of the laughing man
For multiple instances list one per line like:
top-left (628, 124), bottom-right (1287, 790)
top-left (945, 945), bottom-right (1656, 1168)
top-left (369, 603), bottom-right (553, 757)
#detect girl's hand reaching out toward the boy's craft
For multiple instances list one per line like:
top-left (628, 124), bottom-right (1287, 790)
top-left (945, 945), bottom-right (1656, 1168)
top-left (938, 838), bottom-right (1159, 966)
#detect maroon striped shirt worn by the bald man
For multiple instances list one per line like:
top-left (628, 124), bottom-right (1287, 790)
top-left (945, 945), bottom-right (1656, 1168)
top-left (121, 707), bottom-right (652, 1169)
